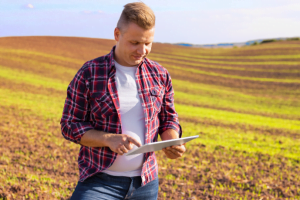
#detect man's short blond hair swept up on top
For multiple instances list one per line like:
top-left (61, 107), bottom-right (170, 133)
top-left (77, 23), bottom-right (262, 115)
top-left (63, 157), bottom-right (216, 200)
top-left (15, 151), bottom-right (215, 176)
top-left (117, 2), bottom-right (155, 30)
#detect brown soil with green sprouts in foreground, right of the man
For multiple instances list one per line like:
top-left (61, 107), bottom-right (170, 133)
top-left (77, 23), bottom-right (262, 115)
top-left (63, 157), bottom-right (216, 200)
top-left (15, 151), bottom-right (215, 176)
top-left (158, 145), bottom-right (300, 200)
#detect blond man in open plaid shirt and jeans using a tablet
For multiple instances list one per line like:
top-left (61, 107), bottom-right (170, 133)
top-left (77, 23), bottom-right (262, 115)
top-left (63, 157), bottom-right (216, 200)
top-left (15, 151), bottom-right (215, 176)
top-left (61, 2), bottom-right (185, 200)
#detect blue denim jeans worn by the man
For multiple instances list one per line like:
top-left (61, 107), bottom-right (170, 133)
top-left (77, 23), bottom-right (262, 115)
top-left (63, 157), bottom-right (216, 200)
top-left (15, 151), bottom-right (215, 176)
top-left (70, 173), bottom-right (158, 200)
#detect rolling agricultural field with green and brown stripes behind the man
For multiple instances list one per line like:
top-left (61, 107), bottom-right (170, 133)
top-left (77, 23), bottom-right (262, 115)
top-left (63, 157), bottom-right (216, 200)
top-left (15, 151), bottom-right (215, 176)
top-left (0, 37), bottom-right (300, 200)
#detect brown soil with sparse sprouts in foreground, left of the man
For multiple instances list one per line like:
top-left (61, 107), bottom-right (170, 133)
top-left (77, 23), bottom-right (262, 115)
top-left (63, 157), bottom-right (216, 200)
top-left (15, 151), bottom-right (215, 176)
top-left (0, 106), bottom-right (78, 199)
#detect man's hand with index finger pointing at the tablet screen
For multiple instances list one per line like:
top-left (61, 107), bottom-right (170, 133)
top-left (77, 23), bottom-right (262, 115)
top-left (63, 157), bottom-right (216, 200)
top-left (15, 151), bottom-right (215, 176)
top-left (107, 134), bottom-right (142, 155)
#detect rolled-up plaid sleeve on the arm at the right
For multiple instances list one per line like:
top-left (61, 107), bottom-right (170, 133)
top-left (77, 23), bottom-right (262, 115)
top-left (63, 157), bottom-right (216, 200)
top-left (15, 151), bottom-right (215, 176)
top-left (159, 72), bottom-right (182, 138)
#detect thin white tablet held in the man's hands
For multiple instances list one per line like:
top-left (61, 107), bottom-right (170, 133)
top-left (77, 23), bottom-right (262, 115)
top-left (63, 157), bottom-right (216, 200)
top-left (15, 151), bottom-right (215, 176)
top-left (125, 135), bottom-right (199, 156)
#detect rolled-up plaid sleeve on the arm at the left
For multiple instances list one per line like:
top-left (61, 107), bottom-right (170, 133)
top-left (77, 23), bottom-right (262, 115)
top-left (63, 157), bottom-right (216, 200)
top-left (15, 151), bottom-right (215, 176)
top-left (60, 66), bottom-right (94, 144)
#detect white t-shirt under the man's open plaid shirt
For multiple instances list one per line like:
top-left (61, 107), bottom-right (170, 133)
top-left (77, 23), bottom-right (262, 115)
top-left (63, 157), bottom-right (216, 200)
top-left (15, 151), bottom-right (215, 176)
top-left (103, 62), bottom-right (145, 177)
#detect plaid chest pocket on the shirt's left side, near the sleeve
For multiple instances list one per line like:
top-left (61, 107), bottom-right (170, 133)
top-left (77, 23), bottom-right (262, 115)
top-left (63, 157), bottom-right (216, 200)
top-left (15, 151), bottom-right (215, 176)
top-left (91, 92), bottom-right (117, 119)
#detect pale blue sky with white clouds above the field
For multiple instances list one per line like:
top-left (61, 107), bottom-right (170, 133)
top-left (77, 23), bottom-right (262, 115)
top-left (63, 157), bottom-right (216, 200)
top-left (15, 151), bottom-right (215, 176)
top-left (0, 0), bottom-right (300, 44)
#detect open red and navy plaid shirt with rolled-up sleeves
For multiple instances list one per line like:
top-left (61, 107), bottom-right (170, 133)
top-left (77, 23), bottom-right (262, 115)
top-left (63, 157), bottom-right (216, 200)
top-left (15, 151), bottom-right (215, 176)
top-left (60, 46), bottom-right (182, 185)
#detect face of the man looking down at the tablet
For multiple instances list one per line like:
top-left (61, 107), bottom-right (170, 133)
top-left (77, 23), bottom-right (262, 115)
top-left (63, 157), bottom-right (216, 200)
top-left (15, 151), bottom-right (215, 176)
top-left (114, 23), bottom-right (154, 66)
